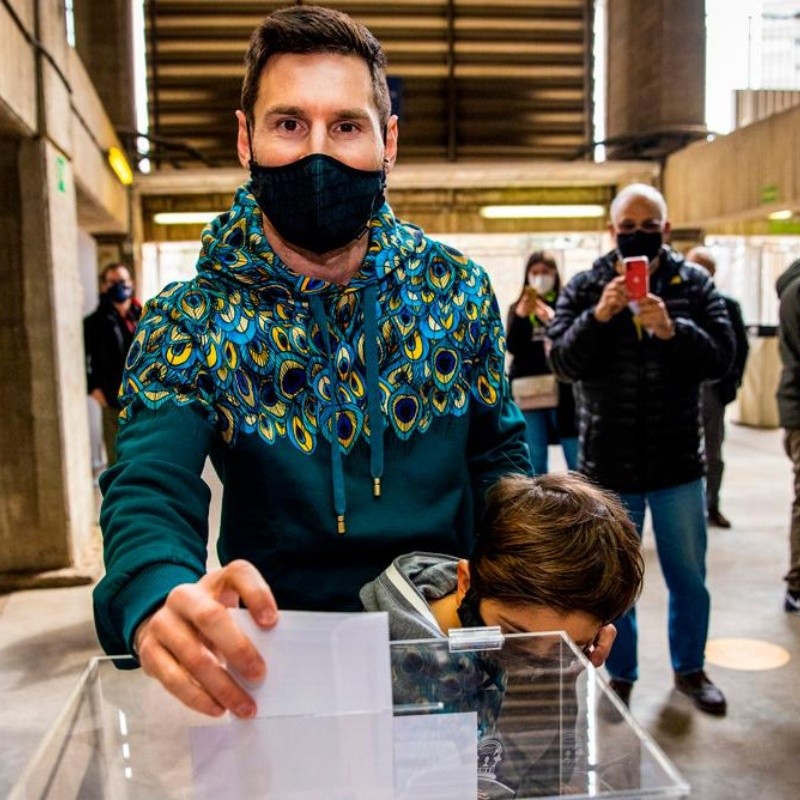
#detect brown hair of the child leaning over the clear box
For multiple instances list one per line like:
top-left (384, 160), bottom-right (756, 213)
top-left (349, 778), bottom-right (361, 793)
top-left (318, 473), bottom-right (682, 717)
top-left (469, 473), bottom-right (644, 623)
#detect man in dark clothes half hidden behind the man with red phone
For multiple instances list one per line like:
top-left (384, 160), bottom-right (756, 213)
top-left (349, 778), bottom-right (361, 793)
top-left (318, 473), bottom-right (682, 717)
top-left (686, 247), bottom-right (750, 528)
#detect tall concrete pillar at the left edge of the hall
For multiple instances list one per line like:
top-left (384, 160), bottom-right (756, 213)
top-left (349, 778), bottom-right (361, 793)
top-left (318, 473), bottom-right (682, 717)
top-left (0, 0), bottom-right (97, 591)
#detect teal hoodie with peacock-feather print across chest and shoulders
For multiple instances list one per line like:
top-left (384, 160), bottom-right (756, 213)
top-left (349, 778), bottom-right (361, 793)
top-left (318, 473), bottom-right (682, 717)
top-left (94, 187), bottom-right (530, 653)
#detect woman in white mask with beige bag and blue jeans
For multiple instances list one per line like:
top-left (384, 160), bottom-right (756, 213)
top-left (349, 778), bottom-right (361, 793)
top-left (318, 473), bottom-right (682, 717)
top-left (506, 251), bottom-right (578, 475)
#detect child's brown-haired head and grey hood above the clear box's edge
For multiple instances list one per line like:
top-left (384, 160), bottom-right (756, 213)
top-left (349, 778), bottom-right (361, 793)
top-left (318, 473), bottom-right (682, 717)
top-left (360, 473), bottom-right (644, 649)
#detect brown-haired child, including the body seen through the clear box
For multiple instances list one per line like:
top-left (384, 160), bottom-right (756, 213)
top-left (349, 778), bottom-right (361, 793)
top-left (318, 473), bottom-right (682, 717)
top-left (361, 473), bottom-right (644, 798)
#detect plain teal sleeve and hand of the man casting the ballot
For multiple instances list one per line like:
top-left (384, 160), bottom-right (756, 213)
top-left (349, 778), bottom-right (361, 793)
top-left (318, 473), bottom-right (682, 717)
top-left (94, 405), bottom-right (277, 717)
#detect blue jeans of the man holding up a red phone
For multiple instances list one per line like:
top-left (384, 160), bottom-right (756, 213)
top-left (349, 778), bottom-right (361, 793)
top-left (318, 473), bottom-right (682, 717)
top-left (606, 479), bottom-right (711, 682)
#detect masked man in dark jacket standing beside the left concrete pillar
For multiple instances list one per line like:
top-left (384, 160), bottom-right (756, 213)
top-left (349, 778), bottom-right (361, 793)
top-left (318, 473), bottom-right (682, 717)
top-left (83, 263), bottom-right (142, 466)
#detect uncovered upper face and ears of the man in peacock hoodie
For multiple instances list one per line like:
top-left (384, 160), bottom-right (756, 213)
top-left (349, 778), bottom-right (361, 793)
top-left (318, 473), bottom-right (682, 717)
top-left (236, 53), bottom-right (397, 172)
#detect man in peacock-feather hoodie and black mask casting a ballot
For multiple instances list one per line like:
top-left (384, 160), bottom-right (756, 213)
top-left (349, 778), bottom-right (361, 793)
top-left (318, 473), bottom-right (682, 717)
top-left (95, 6), bottom-right (576, 717)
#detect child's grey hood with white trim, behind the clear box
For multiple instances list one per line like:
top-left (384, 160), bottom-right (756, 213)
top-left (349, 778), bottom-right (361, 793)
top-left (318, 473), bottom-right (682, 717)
top-left (359, 553), bottom-right (459, 640)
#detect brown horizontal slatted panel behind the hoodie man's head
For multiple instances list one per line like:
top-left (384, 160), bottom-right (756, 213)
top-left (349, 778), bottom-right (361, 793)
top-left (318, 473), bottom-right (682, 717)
top-left (146, 0), bottom-right (593, 169)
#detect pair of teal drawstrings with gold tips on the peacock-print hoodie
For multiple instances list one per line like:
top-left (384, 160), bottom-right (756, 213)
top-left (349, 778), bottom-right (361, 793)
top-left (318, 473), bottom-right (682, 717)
top-left (309, 285), bottom-right (385, 534)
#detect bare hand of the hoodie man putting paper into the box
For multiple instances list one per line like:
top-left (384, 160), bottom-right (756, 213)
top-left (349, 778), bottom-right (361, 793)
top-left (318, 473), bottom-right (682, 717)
top-left (135, 560), bottom-right (278, 718)
